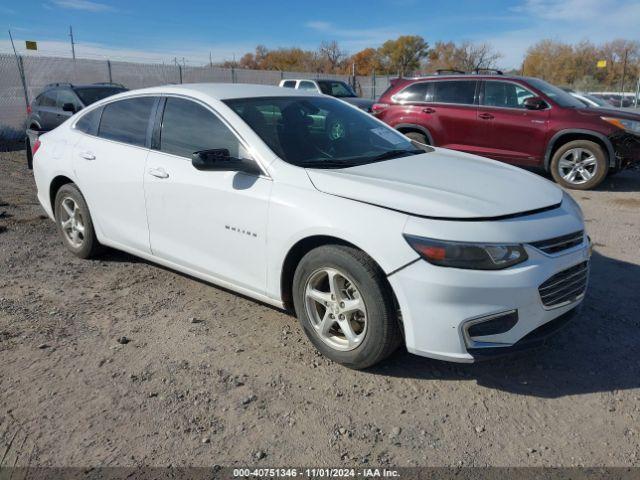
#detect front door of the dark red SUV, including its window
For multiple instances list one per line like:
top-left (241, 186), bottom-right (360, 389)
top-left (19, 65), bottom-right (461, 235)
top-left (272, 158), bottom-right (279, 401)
top-left (478, 79), bottom-right (549, 165)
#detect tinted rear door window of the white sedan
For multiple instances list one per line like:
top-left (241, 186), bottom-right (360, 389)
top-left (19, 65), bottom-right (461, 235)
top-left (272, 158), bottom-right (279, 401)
top-left (98, 97), bottom-right (156, 147)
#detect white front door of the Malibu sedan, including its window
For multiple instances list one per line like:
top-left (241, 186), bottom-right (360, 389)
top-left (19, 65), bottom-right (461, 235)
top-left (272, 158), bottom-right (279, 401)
top-left (144, 97), bottom-right (272, 293)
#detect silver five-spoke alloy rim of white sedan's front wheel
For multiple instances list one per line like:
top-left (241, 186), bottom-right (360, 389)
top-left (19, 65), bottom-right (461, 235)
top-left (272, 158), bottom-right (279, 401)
top-left (305, 268), bottom-right (367, 351)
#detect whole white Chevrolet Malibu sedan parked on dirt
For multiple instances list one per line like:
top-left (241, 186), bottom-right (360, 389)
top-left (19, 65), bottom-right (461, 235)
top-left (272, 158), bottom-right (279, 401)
top-left (34, 84), bottom-right (590, 368)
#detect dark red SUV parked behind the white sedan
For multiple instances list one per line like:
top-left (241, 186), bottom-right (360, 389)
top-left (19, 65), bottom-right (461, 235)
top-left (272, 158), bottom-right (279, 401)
top-left (373, 72), bottom-right (640, 190)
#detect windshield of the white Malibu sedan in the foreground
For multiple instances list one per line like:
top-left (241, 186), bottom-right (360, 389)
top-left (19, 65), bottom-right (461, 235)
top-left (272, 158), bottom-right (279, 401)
top-left (225, 96), bottom-right (426, 168)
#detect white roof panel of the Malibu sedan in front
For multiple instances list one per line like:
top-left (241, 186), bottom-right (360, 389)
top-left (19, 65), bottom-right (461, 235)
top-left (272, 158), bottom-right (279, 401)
top-left (129, 83), bottom-right (317, 100)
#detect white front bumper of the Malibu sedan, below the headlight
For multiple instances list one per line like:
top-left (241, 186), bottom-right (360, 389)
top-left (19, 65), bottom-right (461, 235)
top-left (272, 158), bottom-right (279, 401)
top-left (389, 235), bottom-right (590, 362)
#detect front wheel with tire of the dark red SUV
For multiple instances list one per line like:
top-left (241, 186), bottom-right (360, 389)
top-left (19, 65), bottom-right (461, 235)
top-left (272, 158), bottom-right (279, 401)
top-left (550, 140), bottom-right (609, 190)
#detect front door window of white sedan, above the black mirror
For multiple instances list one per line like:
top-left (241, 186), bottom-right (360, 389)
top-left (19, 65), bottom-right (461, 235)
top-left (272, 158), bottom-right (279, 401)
top-left (160, 97), bottom-right (248, 158)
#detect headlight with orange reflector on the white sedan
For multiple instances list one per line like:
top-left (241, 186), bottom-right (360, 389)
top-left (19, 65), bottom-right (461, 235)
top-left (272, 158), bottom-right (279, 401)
top-left (404, 235), bottom-right (528, 270)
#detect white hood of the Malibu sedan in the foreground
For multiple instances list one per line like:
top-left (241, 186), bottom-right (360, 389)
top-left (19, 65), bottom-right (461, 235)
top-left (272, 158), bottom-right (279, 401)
top-left (307, 149), bottom-right (562, 219)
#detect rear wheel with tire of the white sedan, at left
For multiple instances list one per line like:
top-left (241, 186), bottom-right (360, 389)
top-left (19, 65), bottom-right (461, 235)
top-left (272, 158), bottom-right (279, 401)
top-left (54, 183), bottom-right (101, 258)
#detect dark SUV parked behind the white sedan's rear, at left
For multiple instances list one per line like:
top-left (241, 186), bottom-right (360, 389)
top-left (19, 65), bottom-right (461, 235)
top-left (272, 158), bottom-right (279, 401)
top-left (27, 83), bottom-right (127, 132)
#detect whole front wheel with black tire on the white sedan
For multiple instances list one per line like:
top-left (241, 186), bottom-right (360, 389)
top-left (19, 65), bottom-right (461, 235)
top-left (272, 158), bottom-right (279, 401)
top-left (293, 245), bottom-right (402, 369)
